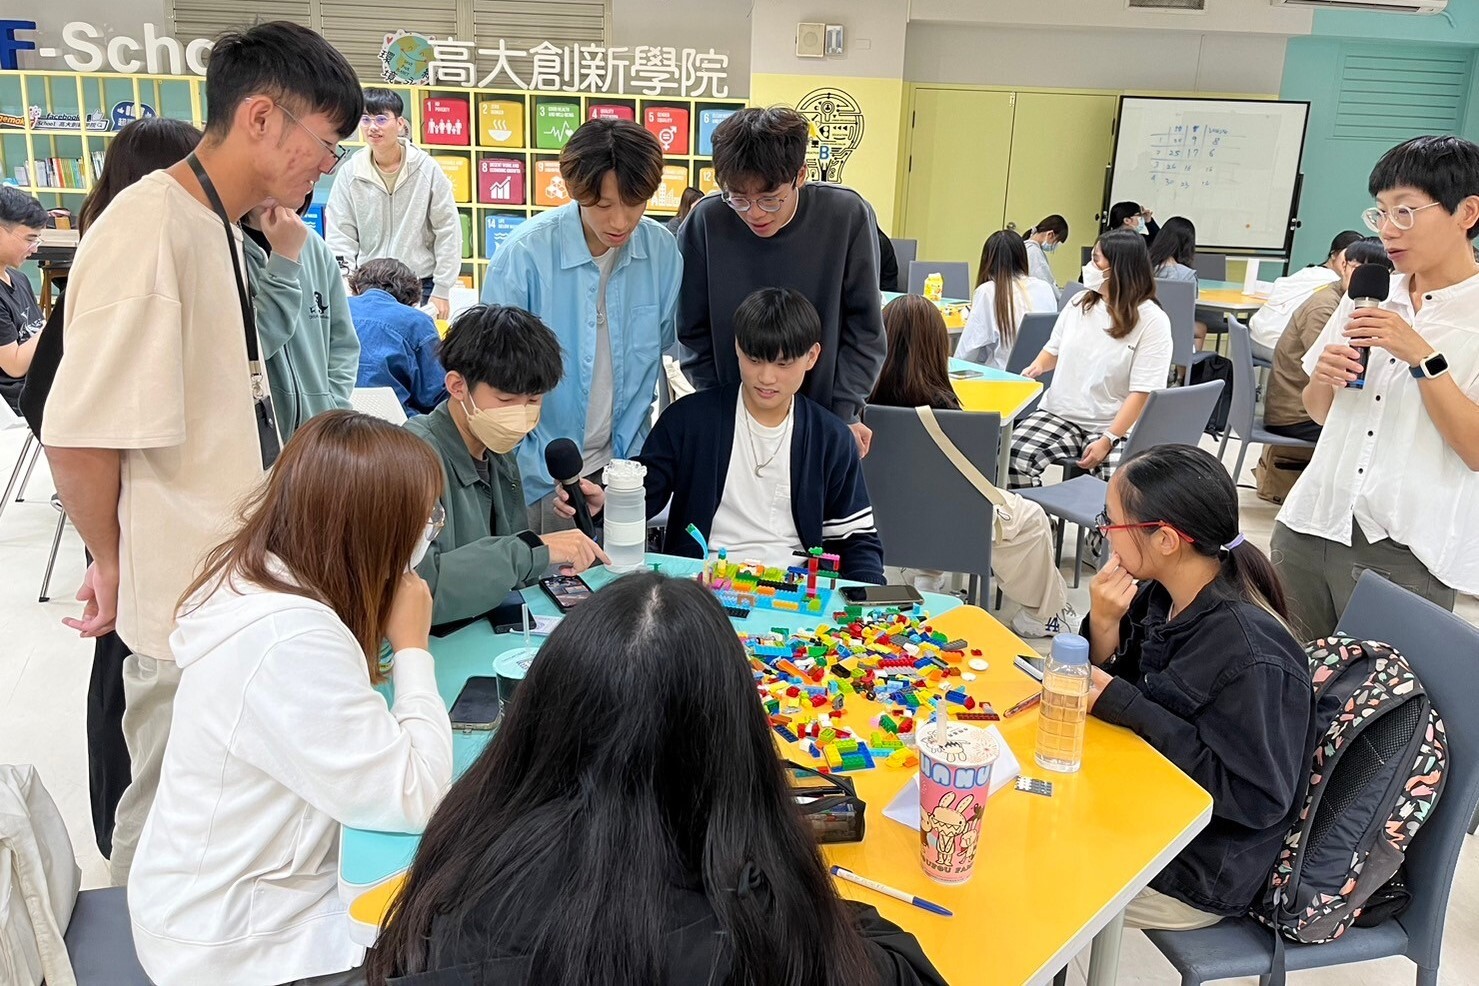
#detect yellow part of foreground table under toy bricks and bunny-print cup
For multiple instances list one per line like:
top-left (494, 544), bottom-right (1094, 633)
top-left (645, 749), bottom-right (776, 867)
top-left (346, 606), bottom-right (1211, 986)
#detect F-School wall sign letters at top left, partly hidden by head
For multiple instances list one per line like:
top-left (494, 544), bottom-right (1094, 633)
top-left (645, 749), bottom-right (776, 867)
top-left (0, 21), bottom-right (214, 75)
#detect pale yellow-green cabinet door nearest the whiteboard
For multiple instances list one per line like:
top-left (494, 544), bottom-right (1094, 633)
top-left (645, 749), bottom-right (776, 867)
top-left (1006, 93), bottom-right (1117, 284)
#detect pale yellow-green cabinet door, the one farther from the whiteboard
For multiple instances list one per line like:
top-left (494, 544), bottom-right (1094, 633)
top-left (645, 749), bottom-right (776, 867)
top-left (899, 87), bottom-right (1013, 277)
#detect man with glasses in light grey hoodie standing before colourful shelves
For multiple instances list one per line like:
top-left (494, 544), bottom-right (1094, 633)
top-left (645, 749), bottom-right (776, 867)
top-left (324, 89), bottom-right (461, 318)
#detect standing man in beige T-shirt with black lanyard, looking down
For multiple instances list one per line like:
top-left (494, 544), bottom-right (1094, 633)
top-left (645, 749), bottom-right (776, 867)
top-left (43, 21), bottom-right (362, 884)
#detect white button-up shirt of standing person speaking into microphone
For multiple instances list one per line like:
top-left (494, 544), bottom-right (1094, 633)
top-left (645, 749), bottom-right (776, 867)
top-left (1277, 273), bottom-right (1479, 594)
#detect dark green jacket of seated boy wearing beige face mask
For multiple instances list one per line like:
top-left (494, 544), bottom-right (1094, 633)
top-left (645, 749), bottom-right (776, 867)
top-left (405, 401), bottom-right (550, 624)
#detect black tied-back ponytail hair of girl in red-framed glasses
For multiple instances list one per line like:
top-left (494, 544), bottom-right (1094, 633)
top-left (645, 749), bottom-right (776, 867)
top-left (1115, 445), bottom-right (1290, 627)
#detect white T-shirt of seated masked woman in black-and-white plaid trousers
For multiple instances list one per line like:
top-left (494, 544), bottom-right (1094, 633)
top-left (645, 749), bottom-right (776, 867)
top-left (1043, 300), bottom-right (1171, 432)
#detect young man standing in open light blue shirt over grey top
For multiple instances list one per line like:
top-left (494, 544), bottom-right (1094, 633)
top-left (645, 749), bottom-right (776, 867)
top-left (482, 120), bottom-right (683, 534)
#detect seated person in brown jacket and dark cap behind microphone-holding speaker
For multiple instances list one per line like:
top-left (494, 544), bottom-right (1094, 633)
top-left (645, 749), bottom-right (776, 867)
top-left (1263, 237), bottom-right (1392, 442)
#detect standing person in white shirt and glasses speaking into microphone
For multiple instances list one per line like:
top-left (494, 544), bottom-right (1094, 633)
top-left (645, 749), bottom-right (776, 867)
top-left (1270, 136), bottom-right (1479, 637)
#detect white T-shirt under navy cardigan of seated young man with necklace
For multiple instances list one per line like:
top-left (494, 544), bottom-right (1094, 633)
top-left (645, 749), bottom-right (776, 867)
top-left (708, 393), bottom-right (802, 568)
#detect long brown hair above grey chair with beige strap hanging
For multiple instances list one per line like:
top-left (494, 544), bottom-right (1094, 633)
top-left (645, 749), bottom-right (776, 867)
top-left (868, 292), bottom-right (958, 411)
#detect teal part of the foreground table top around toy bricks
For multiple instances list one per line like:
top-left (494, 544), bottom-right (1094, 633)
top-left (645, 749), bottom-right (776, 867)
top-left (339, 555), bottom-right (964, 887)
